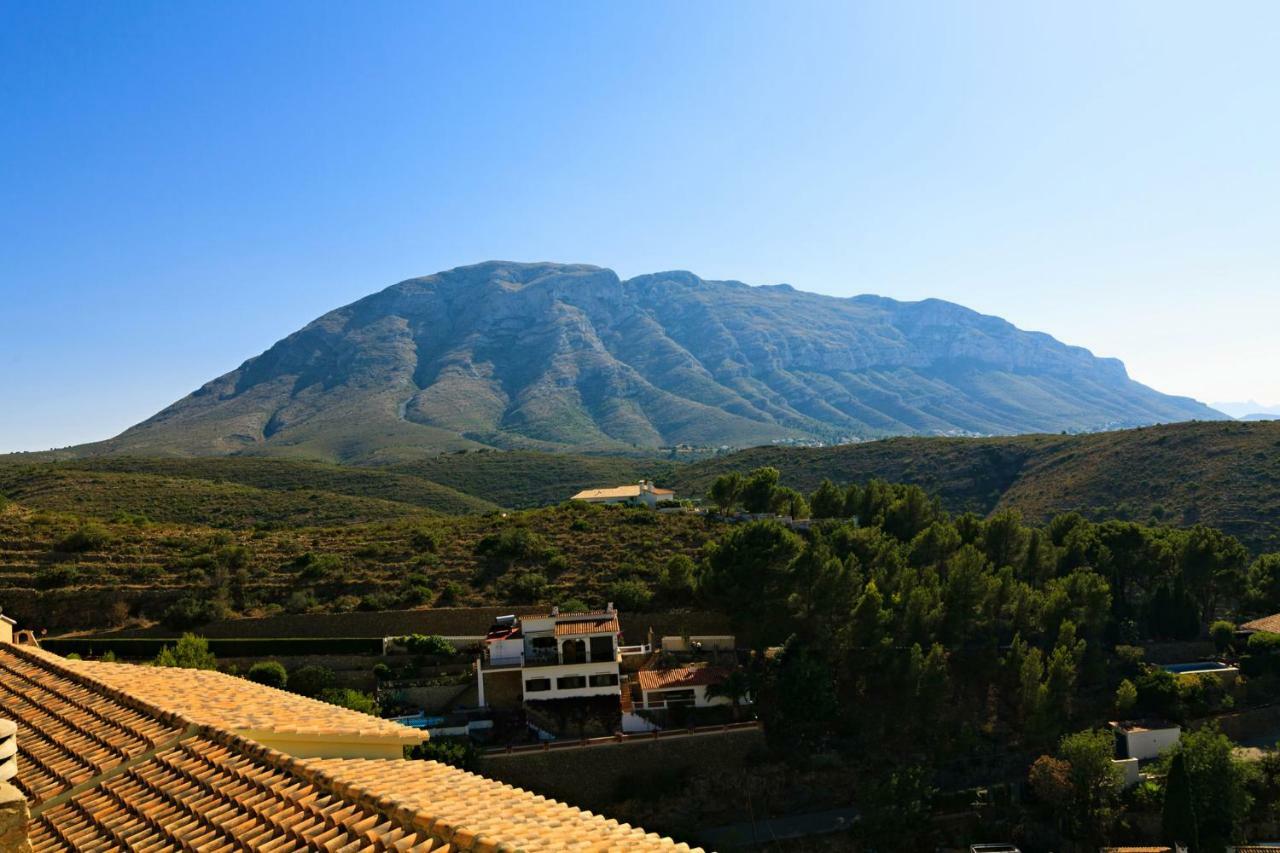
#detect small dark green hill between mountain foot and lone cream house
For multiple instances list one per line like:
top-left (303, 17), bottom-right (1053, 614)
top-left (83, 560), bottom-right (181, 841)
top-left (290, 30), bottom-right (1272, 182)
top-left (390, 451), bottom-right (678, 508)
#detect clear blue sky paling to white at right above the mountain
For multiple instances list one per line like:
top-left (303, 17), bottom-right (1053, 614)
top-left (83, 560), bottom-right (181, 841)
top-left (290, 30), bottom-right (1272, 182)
top-left (0, 0), bottom-right (1280, 451)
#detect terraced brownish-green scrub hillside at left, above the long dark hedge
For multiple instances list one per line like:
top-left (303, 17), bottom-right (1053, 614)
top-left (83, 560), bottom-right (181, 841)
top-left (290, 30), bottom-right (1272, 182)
top-left (0, 494), bottom-right (722, 629)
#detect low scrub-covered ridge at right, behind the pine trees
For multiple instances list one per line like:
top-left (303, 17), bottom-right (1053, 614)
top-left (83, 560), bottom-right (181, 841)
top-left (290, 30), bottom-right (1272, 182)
top-left (671, 421), bottom-right (1280, 551)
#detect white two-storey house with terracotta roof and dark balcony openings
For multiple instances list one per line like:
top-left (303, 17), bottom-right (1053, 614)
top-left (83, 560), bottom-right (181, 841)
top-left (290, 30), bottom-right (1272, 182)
top-left (480, 603), bottom-right (622, 704)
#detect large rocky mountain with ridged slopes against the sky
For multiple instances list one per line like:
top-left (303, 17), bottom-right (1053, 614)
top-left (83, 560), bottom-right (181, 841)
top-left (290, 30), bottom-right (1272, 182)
top-left (82, 261), bottom-right (1221, 462)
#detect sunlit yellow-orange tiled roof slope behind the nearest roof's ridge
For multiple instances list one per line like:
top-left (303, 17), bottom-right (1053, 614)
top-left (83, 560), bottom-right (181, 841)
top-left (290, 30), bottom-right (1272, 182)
top-left (59, 650), bottom-right (426, 745)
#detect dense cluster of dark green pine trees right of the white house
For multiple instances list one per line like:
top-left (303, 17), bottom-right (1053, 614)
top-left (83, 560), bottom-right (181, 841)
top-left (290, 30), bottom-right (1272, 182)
top-left (696, 479), bottom-right (1280, 838)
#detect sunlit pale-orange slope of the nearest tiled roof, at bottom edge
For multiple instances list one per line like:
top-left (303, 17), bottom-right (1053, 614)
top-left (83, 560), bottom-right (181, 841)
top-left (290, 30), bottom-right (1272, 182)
top-left (307, 758), bottom-right (690, 853)
